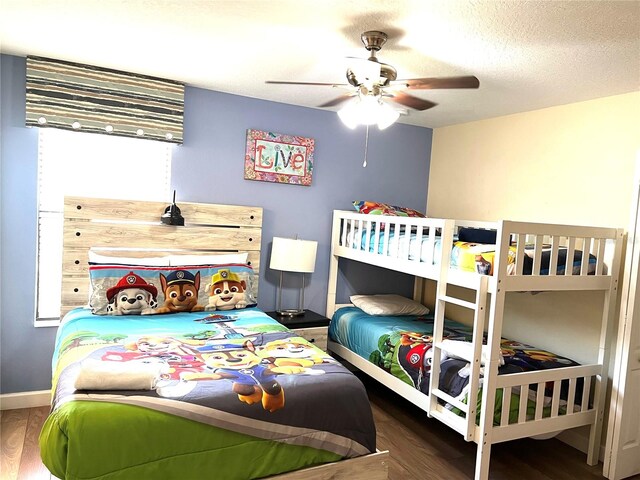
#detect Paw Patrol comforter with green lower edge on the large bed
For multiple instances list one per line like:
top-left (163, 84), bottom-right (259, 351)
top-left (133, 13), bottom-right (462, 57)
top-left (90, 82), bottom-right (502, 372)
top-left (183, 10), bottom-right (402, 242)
top-left (40, 308), bottom-right (375, 479)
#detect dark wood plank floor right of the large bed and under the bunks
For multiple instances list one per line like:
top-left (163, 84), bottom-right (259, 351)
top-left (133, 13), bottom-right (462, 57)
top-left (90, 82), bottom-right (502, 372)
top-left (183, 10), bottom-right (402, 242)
top-left (357, 374), bottom-right (604, 480)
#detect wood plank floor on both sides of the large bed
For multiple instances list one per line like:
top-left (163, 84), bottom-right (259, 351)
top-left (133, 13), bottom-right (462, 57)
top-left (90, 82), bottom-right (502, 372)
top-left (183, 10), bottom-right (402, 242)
top-left (0, 386), bottom-right (616, 480)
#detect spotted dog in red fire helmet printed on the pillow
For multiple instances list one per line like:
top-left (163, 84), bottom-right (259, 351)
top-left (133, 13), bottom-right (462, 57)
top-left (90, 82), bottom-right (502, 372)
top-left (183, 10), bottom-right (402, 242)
top-left (107, 272), bottom-right (158, 315)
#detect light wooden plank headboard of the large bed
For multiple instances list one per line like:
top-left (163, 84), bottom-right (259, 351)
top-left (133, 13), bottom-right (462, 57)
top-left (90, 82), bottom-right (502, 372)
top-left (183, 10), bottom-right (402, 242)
top-left (60, 197), bottom-right (262, 318)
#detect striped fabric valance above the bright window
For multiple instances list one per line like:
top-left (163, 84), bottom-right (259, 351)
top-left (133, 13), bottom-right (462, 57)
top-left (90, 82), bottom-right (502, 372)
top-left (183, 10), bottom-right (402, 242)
top-left (27, 56), bottom-right (184, 144)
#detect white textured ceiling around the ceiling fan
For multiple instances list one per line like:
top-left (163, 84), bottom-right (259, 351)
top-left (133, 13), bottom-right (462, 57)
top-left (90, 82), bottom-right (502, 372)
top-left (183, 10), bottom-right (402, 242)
top-left (0, 0), bottom-right (640, 127)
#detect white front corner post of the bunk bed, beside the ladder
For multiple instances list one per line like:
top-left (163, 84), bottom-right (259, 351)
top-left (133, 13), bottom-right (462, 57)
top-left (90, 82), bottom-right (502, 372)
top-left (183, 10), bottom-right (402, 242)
top-left (476, 221), bottom-right (509, 480)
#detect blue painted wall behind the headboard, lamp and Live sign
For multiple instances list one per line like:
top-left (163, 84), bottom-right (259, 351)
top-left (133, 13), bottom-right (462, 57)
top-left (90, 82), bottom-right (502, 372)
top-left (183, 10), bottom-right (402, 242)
top-left (0, 55), bottom-right (432, 393)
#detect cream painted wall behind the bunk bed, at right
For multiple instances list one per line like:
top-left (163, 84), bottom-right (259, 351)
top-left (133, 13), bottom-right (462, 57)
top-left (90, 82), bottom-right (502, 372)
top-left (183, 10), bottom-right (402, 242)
top-left (427, 92), bottom-right (640, 362)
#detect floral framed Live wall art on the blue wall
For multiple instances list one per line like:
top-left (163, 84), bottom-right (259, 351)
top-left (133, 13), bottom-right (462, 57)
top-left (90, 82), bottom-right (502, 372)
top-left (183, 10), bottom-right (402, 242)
top-left (244, 129), bottom-right (315, 186)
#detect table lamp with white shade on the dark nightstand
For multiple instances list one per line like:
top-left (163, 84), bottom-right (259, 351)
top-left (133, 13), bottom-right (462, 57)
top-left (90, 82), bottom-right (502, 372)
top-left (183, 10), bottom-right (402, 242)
top-left (269, 237), bottom-right (318, 317)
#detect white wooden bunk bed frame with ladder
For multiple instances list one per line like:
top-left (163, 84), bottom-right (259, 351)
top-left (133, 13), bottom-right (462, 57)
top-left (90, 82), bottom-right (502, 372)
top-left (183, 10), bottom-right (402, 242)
top-left (327, 210), bottom-right (623, 480)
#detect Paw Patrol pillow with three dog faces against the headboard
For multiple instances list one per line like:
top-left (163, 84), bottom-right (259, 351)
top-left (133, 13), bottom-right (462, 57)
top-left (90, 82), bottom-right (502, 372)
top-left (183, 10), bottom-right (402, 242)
top-left (89, 263), bottom-right (257, 315)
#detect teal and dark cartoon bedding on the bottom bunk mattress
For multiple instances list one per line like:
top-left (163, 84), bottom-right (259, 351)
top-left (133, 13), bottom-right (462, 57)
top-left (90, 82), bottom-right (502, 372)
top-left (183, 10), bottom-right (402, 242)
top-left (329, 307), bottom-right (582, 425)
